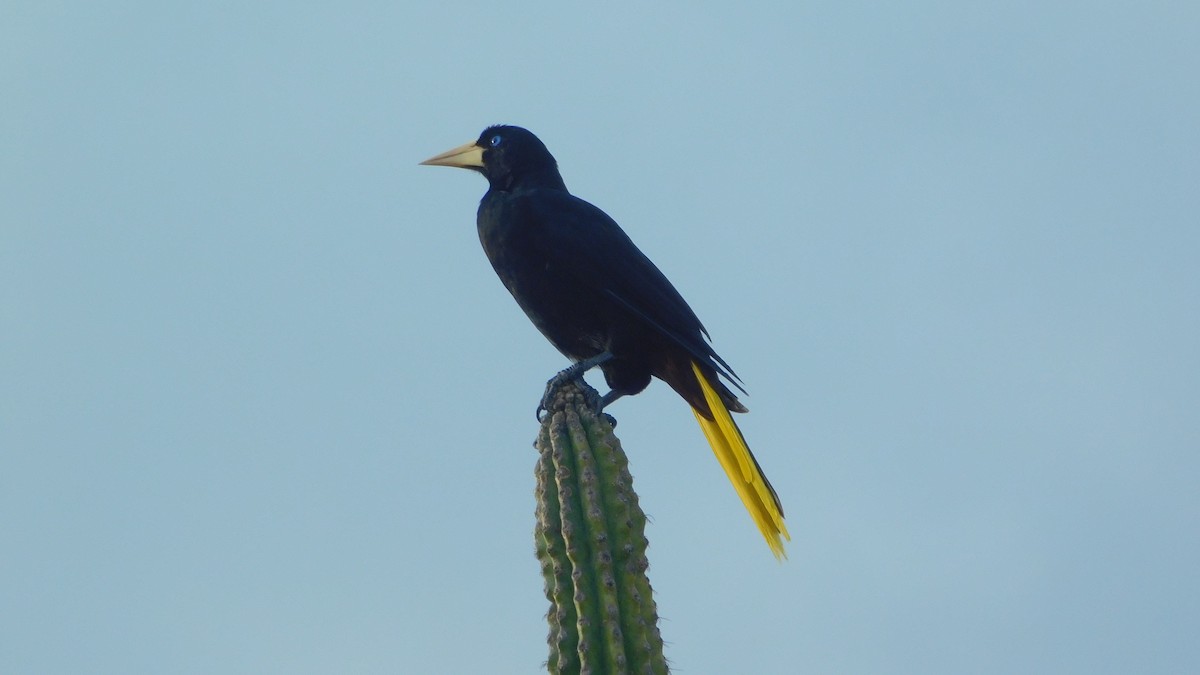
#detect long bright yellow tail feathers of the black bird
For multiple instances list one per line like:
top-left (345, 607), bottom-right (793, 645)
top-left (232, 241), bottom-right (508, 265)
top-left (691, 362), bottom-right (792, 558)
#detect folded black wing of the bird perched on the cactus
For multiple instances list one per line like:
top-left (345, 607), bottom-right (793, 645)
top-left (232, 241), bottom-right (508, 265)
top-left (518, 190), bottom-right (745, 393)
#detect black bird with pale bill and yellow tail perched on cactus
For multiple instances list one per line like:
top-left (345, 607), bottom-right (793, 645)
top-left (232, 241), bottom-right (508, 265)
top-left (421, 125), bottom-right (791, 560)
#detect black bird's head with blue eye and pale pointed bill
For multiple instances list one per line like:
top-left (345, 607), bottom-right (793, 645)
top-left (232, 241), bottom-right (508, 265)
top-left (421, 125), bottom-right (563, 190)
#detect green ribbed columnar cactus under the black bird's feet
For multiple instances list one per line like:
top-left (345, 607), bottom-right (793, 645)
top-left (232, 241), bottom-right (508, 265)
top-left (534, 381), bottom-right (667, 675)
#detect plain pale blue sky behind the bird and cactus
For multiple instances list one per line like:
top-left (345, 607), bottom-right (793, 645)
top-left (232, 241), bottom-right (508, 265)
top-left (0, 0), bottom-right (1200, 674)
